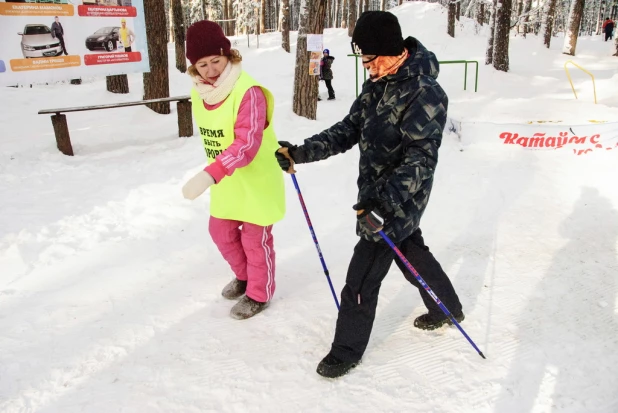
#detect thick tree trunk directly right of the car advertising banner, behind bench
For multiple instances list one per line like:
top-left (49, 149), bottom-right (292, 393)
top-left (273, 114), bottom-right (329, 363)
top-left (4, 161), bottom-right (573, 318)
top-left (144, 0), bottom-right (170, 114)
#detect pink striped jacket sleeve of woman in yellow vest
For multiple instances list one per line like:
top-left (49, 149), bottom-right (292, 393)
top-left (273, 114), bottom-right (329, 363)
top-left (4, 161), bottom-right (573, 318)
top-left (204, 86), bottom-right (268, 183)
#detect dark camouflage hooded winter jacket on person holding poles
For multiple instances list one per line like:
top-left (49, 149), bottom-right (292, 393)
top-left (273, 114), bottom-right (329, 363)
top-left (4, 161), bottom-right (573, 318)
top-left (303, 37), bottom-right (448, 242)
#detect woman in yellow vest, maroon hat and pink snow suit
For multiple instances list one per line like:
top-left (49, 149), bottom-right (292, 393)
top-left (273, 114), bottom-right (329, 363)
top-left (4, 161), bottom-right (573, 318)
top-left (182, 20), bottom-right (285, 319)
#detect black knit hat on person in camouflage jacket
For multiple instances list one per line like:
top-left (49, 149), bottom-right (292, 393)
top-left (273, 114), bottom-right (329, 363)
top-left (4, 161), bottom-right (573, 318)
top-left (352, 11), bottom-right (403, 56)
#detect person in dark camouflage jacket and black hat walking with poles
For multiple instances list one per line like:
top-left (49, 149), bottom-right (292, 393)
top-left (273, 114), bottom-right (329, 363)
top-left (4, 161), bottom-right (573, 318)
top-left (275, 11), bottom-right (464, 377)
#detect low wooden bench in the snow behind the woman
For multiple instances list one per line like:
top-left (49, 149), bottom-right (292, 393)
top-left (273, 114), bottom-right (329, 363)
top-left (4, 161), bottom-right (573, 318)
top-left (39, 95), bottom-right (193, 156)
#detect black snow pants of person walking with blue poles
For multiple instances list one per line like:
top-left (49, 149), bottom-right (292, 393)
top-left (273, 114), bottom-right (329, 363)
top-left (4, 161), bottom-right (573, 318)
top-left (331, 229), bottom-right (462, 362)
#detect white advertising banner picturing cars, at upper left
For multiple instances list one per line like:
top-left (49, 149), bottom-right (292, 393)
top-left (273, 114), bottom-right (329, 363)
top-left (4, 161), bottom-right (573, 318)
top-left (0, 0), bottom-right (149, 86)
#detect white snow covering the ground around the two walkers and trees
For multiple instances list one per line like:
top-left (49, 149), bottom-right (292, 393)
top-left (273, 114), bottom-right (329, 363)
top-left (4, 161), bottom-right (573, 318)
top-left (0, 3), bottom-right (618, 413)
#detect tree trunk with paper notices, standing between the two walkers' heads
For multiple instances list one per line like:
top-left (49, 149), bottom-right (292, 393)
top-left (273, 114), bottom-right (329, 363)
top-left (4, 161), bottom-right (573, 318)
top-left (292, 0), bottom-right (326, 119)
